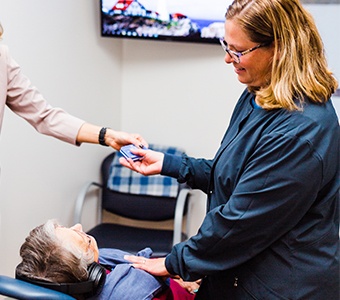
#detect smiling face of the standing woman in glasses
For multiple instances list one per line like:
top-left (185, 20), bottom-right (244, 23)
top-left (224, 19), bottom-right (274, 88)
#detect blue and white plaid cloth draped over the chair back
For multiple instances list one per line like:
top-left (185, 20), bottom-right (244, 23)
top-left (107, 145), bottom-right (184, 198)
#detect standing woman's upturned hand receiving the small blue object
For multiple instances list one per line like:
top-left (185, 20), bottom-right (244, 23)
top-left (119, 149), bottom-right (164, 175)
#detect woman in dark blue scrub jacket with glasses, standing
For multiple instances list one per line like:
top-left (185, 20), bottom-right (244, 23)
top-left (121, 0), bottom-right (340, 300)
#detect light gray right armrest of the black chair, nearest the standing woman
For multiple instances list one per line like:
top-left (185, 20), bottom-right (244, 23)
top-left (172, 188), bottom-right (191, 245)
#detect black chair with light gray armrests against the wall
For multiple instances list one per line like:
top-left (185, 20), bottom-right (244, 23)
top-left (74, 145), bottom-right (192, 256)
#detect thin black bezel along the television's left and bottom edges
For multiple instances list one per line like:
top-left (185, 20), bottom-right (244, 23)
top-left (99, 0), bottom-right (220, 44)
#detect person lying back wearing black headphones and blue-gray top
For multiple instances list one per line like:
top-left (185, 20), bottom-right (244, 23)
top-left (16, 220), bottom-right (199, 300)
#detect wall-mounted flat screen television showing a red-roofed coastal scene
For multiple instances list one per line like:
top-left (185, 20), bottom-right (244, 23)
top-left (100, 0), bottom-right (232, 43)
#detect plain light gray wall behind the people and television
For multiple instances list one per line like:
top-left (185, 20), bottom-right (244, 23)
top-left (0, 0), bottom-right (340, 276)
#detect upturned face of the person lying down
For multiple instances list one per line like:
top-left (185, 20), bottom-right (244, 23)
top-left (56, 224), bottom-right (99, 262)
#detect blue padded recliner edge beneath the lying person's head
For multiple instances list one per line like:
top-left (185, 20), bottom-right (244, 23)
top-left (0, 275), bottom-right (75, 300)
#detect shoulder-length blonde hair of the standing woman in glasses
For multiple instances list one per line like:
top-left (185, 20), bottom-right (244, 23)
top-left (226, 0), bottom-right (338, 110)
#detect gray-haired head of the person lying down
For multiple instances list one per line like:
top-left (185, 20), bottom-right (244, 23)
top-left (16, 220), bottom-right (98, 283)
